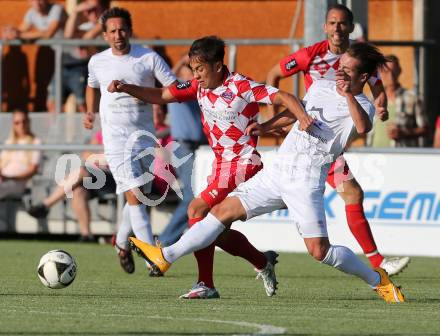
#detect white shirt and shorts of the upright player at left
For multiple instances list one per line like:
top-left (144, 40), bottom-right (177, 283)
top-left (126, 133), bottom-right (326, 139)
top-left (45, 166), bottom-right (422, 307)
top-left (88, 45), bottom-right (176, 194)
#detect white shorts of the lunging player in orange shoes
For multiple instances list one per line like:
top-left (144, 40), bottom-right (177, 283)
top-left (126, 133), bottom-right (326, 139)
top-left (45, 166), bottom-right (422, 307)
top-left (233, 161), bottom-right (328, 238)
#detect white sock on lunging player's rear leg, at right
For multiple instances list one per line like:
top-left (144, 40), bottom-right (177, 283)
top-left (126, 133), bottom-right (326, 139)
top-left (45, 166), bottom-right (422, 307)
top-left (322, 245), bottom-right (380, 288)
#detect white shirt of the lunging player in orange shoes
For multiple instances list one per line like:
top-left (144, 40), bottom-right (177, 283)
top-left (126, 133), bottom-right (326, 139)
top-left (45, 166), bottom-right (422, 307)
top-left (279, 80), bottom-right (375, 163)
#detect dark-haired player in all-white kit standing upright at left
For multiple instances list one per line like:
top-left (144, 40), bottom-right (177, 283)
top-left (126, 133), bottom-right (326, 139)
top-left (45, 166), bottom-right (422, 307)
top-left (84, 7), bottom-right (176, 273)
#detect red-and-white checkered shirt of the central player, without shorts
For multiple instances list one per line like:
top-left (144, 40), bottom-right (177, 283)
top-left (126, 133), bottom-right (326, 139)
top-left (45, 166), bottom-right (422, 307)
top-left (169, 71), bottom-right (278, 164)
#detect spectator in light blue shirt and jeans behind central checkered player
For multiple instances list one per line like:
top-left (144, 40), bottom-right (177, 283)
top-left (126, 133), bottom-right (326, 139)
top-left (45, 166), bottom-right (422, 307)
top-left (159, 57), bottom-right (207, 246)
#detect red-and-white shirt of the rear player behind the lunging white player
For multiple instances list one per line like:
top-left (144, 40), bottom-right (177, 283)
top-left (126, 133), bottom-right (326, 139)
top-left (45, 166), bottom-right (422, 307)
top-left (280, 40), bottom-right (381, 90)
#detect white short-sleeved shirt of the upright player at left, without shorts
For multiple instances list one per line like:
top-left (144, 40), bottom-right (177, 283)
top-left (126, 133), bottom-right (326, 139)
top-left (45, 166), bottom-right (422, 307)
top-left (88, 45), bottom-right (176, 145)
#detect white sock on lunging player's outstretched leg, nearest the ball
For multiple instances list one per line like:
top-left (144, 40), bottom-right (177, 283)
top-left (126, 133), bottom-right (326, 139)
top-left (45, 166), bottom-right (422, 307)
top-left (162, 213), bottom-right (225, 263)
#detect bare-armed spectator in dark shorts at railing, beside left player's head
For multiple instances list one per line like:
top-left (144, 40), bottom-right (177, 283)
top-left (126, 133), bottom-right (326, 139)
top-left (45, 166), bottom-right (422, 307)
top-left (48, 0), bottom-right (110, 112)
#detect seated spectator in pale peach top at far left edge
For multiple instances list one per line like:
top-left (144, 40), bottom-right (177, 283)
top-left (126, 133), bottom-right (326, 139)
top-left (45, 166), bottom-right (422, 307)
top-left (0, 111), bottom-right (41, 199)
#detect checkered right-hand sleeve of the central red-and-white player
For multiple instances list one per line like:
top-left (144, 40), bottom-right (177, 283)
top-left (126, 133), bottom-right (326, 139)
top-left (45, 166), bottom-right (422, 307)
top-left (235, 78), bottom-right (279, 105)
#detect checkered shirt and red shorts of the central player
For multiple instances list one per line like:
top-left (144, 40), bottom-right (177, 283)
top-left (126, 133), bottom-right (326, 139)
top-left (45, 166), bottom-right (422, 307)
top-left (169, 68), bottom-right (278, 207)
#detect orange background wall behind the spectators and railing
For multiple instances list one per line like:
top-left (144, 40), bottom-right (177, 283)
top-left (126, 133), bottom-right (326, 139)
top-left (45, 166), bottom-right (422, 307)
top-left (0, 0), bottom-right (413, 113)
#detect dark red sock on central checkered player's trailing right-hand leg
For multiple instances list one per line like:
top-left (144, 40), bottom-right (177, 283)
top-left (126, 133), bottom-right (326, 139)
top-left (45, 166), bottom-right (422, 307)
top-left (216, 230), bottom-right (267, 270)
